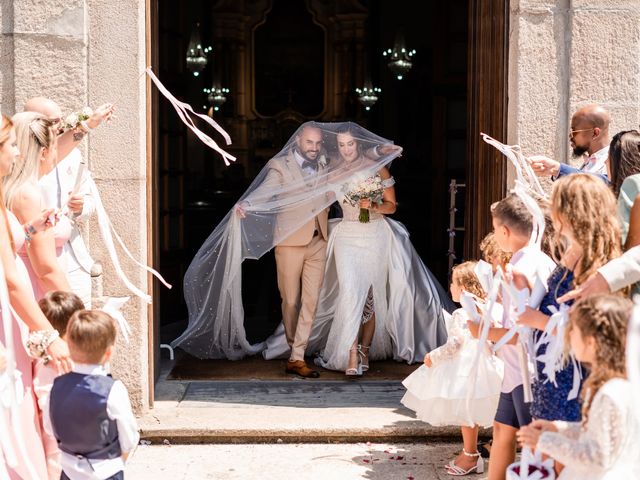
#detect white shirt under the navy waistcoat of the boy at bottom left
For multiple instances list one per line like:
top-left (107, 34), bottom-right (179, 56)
top-left (43, 363), bottom-right (140, 480)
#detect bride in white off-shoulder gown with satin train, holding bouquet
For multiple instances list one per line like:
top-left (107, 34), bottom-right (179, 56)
top-left (263, 124), bottom-right (452, 375)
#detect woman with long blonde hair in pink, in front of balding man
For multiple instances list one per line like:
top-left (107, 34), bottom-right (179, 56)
top-left (4, 112), bottom-right (71, 299)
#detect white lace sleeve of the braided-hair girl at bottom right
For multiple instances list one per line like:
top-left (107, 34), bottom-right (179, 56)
top-left (537, 395), bottom-right (627, 472)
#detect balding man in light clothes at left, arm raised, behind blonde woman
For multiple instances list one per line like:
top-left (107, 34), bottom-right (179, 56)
top-left (24, 97), bottom-right (113, 309)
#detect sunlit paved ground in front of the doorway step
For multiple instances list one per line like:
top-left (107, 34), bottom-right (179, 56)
top-left (126, 443), bottom-right (486, 480)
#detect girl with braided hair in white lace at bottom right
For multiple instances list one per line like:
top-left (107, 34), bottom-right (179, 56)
top-left (518, 295), bottom-right (640, 480)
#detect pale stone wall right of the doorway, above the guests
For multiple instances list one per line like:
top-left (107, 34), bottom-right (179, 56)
top-left (508, 0), bottom-right (640, 178)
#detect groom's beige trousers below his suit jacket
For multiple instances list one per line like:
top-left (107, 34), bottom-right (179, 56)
top-left (275, 235), bottom-right (327, 360)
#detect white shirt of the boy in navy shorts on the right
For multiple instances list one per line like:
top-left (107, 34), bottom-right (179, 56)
top-left (496, 246), bottom-right (556, 393)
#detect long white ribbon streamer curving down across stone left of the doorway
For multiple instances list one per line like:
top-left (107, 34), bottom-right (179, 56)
top-left (89, 178), bottom-right (171, 303)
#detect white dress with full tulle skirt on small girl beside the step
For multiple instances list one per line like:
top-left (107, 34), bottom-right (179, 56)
top-left (402, 308), bottom-right (503, 427)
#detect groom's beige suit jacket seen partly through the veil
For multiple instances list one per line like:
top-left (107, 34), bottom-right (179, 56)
top-left (246, 151), bottom-right (329, 247)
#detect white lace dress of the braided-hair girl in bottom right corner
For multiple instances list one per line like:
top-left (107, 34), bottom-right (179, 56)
top-left (536, 378), bottom-right (640, 480)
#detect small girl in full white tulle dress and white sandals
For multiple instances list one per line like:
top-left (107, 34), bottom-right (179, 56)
top-left (402, 262), bottom-right (502, 475)
